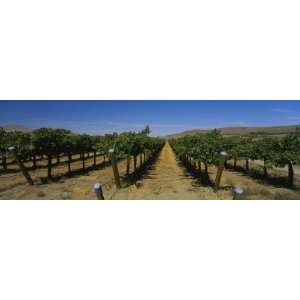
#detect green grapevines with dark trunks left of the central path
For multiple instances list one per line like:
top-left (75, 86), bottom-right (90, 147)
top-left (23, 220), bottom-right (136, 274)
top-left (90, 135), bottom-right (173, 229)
top-left (0, 127), bottom-right (163, 179)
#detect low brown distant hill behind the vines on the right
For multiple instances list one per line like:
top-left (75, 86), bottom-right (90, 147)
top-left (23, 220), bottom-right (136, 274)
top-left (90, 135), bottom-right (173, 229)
top-left (166, 125), bottom-right (300, 138)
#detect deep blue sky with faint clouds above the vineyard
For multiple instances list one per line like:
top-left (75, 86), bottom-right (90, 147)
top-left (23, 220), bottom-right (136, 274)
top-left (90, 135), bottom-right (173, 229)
top-left (0, 100), bottom-right (300, 135)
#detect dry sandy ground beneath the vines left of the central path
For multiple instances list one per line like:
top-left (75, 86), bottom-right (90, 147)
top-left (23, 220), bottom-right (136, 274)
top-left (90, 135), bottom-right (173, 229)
top-left (0, 157), bottom-right (133, 199)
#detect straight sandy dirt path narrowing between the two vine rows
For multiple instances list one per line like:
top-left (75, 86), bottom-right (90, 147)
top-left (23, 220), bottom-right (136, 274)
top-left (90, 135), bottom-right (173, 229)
top-left (114, 143), bottom-right (228, 199)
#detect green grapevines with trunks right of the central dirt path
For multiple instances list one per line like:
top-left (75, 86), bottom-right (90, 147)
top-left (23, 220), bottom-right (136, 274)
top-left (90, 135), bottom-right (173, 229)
top-left (171, 130), bottom-right (300, 188)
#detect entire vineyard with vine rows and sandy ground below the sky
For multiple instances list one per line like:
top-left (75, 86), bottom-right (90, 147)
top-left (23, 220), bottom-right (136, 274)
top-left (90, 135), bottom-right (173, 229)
top-left (0, 126), bottom-right (300, 199)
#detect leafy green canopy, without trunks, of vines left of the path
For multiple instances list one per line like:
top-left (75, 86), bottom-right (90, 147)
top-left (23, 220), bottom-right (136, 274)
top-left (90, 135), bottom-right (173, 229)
top-left (0, 126), bottom-right (164, 159)
